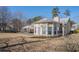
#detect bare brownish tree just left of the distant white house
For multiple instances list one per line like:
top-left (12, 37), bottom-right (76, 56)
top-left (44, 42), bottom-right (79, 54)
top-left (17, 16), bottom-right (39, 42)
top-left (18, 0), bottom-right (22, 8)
top-left (12, 12), bottom-right (23, 32)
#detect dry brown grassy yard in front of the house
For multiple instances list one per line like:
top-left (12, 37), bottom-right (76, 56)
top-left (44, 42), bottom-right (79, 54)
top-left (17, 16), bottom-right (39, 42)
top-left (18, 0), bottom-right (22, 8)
top-left (0, 33), bottom-right (79, 52)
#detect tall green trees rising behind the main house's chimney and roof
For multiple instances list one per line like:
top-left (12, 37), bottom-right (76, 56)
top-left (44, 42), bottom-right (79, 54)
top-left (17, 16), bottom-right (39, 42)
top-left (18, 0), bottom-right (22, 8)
top-left (52, 7), bottom-right (75, 26)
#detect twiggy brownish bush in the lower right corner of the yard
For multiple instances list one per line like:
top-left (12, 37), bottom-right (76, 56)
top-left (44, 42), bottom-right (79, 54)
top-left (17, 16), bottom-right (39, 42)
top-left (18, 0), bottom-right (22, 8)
top-left (65, 36), bottom-right (79, 52)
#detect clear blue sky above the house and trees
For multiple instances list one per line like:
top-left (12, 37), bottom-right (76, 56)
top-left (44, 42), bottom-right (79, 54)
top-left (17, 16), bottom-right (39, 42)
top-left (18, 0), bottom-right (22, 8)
top-left (8, 6), bottom-right (79, 22)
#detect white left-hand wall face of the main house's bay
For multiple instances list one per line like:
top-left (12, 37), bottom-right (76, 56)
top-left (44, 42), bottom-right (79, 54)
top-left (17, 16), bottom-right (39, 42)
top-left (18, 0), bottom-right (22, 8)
top-left (34, 24), bottom-right (48, 36)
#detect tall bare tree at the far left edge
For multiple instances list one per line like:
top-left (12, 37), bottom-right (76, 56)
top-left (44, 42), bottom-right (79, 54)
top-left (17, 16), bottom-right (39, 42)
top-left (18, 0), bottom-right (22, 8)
top-left (0, 6), bottom-right (10, 31)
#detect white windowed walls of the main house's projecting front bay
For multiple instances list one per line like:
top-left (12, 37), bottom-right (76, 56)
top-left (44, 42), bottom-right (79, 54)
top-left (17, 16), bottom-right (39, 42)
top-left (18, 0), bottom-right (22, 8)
top-left (34, 23), bottom-right (60, 36)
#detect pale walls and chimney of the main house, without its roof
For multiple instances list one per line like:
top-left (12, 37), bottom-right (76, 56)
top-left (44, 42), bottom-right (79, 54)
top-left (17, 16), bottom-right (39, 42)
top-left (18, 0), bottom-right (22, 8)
top-left (34, 17), bottom-right (71, 36)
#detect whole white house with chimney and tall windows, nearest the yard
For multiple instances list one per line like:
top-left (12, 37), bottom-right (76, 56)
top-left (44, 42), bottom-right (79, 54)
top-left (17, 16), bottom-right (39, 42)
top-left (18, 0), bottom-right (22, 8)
top-left (34, 16), bottom-right (71, 36)
